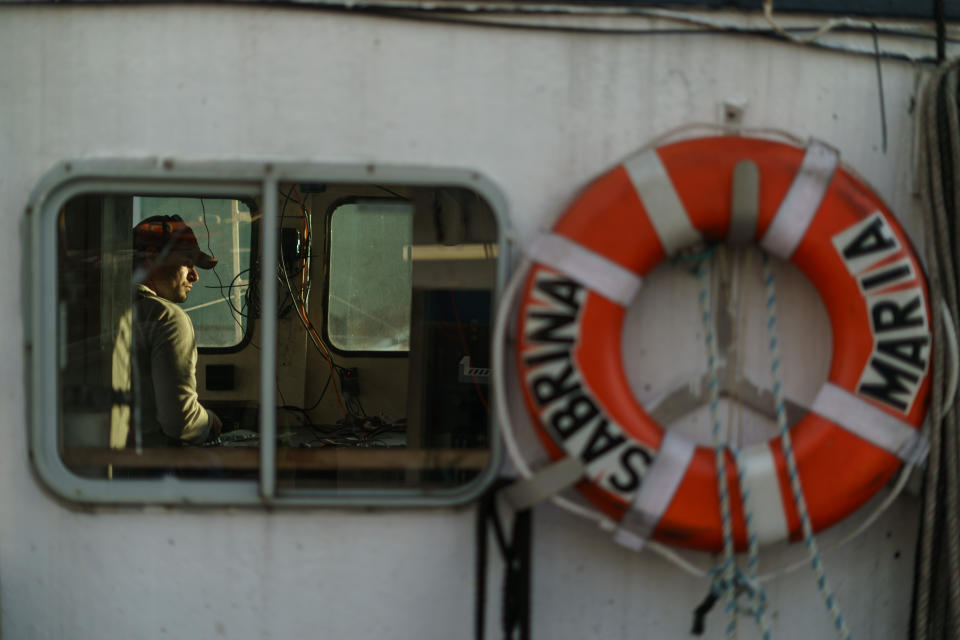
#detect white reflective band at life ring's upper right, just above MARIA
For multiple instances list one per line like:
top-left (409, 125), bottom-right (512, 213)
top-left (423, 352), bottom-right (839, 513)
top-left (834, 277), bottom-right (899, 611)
top-left (760, 140), bottom-right (840, 260)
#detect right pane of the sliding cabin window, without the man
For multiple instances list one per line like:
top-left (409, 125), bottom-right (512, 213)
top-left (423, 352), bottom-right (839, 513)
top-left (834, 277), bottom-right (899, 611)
top-left (277, 184), bottom-right (498, 490)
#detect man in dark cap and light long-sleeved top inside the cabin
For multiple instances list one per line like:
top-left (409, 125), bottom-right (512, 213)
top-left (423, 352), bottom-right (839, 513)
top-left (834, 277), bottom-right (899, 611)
top-left (110, 215), bottom-right (222, 448)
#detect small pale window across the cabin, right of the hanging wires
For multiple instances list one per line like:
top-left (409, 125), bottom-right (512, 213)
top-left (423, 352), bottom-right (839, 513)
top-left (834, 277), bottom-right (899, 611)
top-left (327, 200), bottom-right (413, 351)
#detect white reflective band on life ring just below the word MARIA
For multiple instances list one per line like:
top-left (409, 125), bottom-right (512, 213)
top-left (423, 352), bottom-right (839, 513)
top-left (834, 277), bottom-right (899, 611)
top-left (810, 382), bottom-right (930, 464)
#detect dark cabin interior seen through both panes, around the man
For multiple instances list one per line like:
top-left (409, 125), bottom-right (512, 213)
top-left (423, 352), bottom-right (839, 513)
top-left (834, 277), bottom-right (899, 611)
top-left (58, 182), bottom-right (498, 489)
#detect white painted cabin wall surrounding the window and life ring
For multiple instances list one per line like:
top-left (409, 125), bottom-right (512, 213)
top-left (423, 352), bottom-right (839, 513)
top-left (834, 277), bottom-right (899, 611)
top-left (0, 5), bottom-right (956, 640)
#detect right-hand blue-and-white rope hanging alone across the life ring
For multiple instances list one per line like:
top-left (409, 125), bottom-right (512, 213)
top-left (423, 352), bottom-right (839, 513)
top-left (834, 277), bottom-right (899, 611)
top-left (763, 253), bottom-right (852, 640)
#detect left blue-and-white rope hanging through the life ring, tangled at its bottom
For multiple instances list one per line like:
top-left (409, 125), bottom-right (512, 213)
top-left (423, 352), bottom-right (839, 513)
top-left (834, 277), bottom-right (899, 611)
top-left (697, 255), bottom-right (771, 640)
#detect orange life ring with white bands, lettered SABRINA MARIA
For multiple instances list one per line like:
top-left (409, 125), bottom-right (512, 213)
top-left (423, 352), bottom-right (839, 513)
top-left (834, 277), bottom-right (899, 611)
top-left (516, 136), bottom-right (932, 550)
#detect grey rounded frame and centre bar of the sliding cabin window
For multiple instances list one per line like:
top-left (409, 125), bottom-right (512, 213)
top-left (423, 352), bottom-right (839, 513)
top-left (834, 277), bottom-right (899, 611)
top-left (22, 158), bottom-right (510, 507)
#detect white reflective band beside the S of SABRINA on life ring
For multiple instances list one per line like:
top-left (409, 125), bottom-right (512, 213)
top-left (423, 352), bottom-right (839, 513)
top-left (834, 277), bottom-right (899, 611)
top-left (613, 431), bottom-right (696, 551)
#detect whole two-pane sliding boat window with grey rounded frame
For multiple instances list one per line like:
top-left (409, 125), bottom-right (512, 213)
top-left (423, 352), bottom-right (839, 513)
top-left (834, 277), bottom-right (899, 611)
top-left (29, 163), bottom-right (510, 504)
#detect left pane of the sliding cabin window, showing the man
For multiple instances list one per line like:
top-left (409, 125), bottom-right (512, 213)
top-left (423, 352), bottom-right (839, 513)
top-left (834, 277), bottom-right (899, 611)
top-left (57, 193), bottom-right (259, 479)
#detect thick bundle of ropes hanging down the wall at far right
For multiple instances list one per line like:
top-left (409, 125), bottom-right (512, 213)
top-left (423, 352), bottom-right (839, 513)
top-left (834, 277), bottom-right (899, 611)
top-left (911, 59), bottom-right (960, 640)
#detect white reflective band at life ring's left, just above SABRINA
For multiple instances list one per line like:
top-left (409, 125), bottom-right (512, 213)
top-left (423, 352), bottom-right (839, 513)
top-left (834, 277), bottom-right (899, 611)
top-left (526, 233), bottom-right (643, 307)
